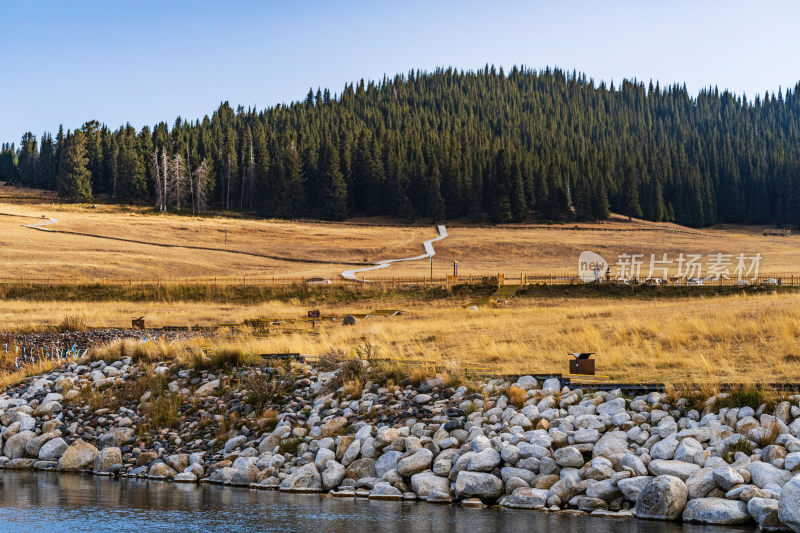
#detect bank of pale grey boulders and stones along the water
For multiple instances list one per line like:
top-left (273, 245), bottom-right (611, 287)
top-left (0, 357), bottom-right (800, 531)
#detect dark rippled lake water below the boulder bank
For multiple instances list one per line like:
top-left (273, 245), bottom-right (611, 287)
top-left (0, 470), bottom-right (748, 533)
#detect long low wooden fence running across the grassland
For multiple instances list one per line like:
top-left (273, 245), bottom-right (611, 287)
top-left (0, 273), bottom-right (800, 289)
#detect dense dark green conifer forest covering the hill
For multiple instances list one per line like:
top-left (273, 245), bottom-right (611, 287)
top-left (0, 67), bottom-right (800, 226)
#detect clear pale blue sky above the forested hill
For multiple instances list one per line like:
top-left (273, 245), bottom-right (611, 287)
top-left (0, 0), bottom-right (800, 143)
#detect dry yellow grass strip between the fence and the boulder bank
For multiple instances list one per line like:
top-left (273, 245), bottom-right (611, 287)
top-left (0, 288), bottom-right (800, 384)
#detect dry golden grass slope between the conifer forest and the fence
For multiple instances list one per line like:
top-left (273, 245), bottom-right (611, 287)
top-left (0, 181), bottom-right (800, 279)
